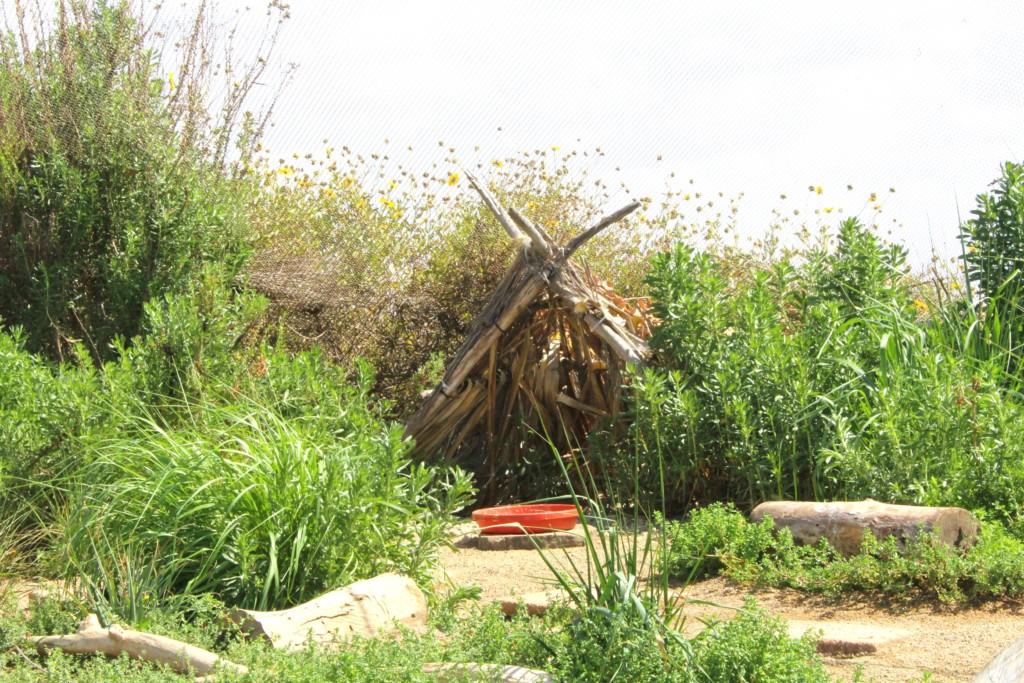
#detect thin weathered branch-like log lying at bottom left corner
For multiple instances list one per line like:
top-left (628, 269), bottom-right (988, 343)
top-left (33, 614), bottom-right (248, 676)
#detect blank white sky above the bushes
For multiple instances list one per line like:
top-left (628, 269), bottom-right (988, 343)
top-left (205, 0), bottom-right (1024, 263)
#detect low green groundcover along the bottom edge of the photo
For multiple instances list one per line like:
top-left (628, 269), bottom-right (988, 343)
top-left (0, 577), bottom-right (830, 683)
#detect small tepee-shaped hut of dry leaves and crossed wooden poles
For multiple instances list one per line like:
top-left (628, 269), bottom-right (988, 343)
top-left (406, 173), bottom-right (651, 503)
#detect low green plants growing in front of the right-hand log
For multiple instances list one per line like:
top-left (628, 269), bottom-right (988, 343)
top-left (662, 504), bottom-right (1024, 603)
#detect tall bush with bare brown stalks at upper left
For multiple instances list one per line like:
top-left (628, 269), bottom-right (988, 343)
top-left (0, 0), bottom-right (278, 359)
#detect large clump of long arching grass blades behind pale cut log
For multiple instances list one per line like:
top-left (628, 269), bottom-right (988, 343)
top-left (56, 355), bottom-right (471, 610)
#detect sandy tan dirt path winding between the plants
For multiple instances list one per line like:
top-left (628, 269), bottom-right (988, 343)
top-left (439, 528), bottom-right (1024, 683)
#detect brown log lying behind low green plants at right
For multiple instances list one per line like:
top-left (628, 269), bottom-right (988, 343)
top-left (751, 499), bottom-right (978, 555)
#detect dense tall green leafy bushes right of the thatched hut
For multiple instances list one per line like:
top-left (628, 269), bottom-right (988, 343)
top-left (618, 220), bottom-right (1024, 523)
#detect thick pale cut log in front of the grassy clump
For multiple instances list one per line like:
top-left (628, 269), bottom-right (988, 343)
top-left (231, 573), bottom-right (427, 650)
